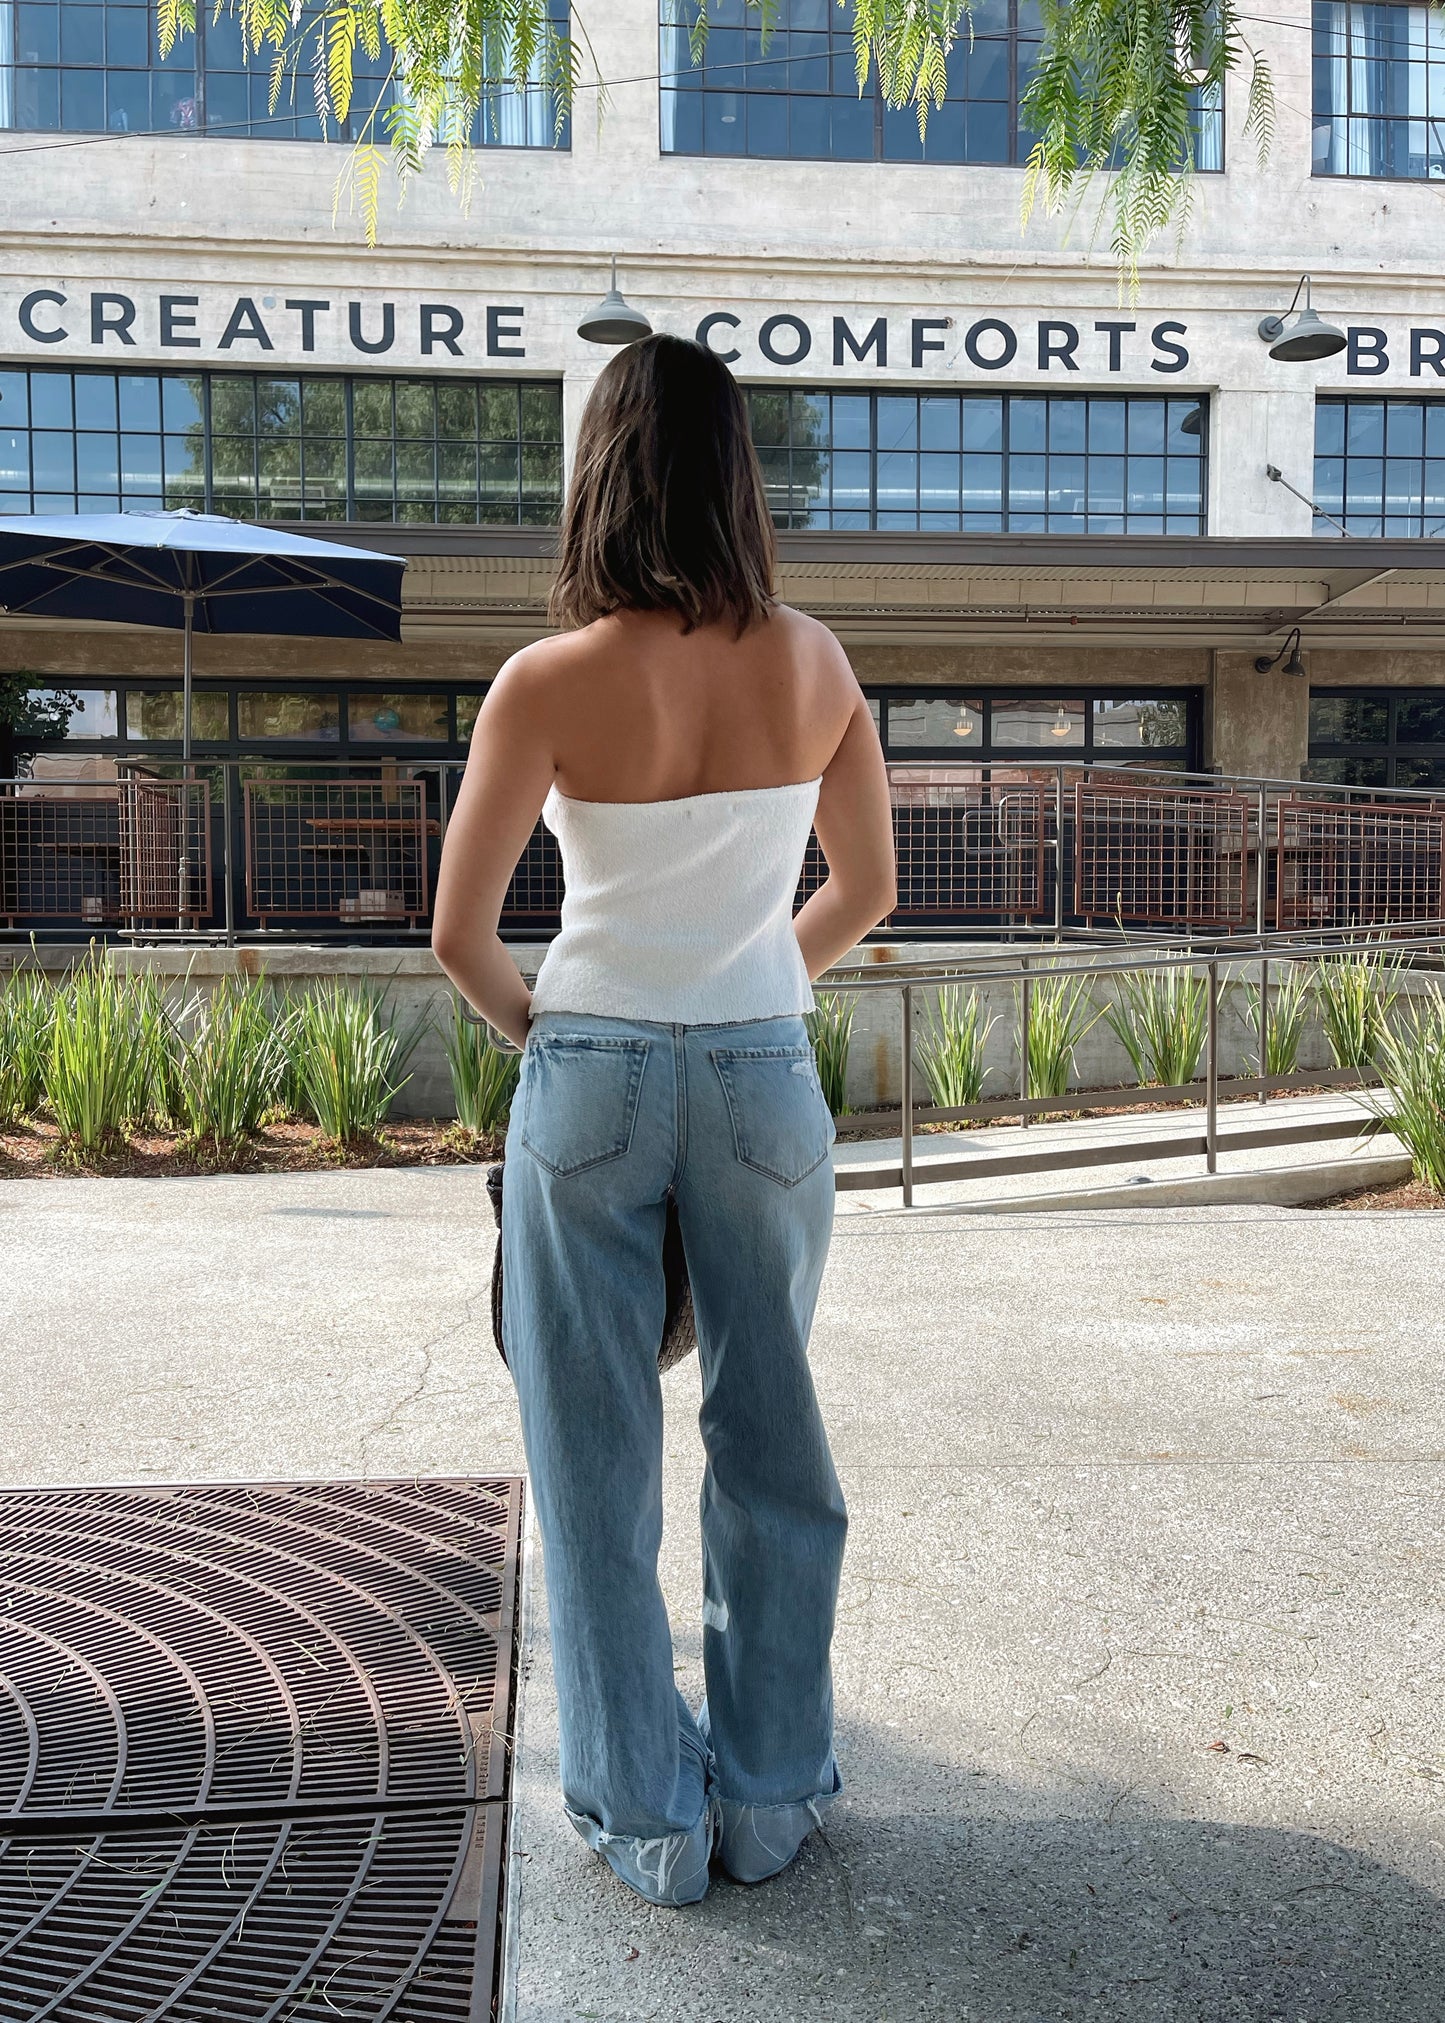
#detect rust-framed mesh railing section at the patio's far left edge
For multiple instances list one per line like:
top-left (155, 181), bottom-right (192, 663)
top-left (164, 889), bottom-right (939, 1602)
top-left (0, 777), bottom-right (213, 929)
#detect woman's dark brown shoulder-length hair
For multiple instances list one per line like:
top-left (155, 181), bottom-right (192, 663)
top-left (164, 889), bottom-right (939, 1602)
top-left (550, 336), bottom-right (777, 637)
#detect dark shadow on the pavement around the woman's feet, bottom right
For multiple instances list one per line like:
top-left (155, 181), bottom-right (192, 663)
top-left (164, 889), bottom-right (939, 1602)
top-left (516, 1726), bottom-right (1445, 2023)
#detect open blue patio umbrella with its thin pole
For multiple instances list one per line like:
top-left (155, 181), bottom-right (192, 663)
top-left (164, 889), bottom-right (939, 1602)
top-left (0, 510), bottom-right (407, 930)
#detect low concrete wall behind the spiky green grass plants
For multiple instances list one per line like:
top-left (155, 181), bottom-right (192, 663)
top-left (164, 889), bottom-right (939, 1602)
top-left (0, 943), bottom-right (1425, 1117)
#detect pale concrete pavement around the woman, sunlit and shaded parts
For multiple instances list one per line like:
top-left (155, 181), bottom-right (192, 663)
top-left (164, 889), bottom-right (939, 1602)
top-left (0, 1169), bottom-right (1445, 2023)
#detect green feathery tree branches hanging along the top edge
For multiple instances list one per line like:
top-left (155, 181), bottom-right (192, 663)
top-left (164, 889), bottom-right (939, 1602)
top-left (158, 0), bottom-right (1275, 291)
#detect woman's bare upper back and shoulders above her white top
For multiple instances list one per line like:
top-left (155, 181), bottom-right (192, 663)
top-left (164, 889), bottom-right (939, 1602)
top-left (526, 607), bottom-right (858, 801)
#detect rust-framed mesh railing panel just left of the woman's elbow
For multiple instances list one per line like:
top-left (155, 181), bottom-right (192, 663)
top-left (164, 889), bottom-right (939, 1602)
top-left (243, 777), bottom-right (437, 929)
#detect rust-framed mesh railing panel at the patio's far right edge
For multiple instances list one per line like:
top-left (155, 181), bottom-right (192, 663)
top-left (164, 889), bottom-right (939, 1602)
top-left (1275, 797), bottom-right (1445, 929)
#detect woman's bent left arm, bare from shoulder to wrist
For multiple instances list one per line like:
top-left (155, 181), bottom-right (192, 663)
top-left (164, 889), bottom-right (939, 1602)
top-left (431, 647), bottom-right (555, 1046)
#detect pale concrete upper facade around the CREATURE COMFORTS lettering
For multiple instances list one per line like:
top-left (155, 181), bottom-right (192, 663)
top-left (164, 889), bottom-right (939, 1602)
top-left (0, 0), bottom-right (1445, 534)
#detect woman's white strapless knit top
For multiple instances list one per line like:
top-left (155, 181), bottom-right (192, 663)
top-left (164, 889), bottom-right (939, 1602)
top-left (532, 777), bottom-right (822, 1026)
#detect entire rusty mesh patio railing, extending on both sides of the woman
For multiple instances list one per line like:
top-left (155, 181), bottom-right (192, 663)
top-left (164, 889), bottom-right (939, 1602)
top-left (0, 757), bottom-right (1445, 939)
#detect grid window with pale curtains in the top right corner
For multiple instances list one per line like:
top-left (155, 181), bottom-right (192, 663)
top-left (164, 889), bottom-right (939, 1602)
top-left (1313, 0), bottom-right (1445, 178)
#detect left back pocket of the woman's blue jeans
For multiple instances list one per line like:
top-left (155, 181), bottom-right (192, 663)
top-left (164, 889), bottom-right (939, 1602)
top-left (520, 1032), bottom-right (648, 1177)
